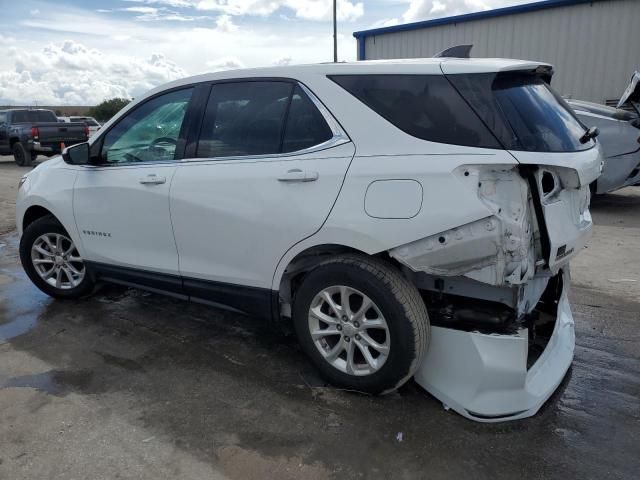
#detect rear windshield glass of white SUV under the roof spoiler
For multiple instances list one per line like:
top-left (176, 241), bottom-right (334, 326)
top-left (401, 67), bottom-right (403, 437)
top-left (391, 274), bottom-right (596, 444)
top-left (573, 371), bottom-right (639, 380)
top-left (448, 73), bottom-right (594, 152)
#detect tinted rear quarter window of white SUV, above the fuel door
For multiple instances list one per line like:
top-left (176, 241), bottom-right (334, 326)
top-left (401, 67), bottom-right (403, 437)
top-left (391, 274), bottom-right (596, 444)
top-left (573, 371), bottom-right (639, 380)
top-left (330, 75), bottom-right (500, 148)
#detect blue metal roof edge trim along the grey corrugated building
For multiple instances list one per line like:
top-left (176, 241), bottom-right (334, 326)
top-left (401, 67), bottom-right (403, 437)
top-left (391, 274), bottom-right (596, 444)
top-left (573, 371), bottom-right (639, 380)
top-left (353, 0), bottom-right (601, 40)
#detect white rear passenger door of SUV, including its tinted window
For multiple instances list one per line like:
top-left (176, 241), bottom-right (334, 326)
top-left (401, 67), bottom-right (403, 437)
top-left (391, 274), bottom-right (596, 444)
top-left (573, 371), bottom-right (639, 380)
top-left (171, 80), bottom-right (355, 313)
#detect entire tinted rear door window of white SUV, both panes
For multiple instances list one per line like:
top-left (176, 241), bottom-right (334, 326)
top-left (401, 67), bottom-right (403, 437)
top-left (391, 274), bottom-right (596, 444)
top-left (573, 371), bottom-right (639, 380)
top-left (197, 81), bottom-right (333, 158)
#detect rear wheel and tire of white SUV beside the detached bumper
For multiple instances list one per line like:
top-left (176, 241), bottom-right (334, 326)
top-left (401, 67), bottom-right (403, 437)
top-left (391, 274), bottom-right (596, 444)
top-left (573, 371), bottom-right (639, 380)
top-left (293, 254), bottom-right (429, 394)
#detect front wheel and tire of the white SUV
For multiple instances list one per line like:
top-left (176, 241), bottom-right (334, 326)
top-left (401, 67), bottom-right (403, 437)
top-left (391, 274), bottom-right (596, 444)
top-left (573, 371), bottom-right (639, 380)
top-left (20, 215), bottom-right (94, 298)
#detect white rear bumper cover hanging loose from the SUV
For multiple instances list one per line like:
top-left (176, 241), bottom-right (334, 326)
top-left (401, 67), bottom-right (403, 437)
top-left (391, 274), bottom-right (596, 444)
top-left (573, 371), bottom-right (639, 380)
top-left (415, 273), bottom-right (575, 422)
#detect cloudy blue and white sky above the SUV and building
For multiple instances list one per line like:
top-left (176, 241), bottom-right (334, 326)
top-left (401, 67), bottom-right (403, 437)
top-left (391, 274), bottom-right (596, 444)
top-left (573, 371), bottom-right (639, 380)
top-left (0, 0), bottom-right (531, 105)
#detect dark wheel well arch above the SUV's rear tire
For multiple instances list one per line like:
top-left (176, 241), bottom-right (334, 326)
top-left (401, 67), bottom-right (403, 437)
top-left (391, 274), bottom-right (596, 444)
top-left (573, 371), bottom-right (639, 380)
top-left (279, 244), bottom-right (396, 316)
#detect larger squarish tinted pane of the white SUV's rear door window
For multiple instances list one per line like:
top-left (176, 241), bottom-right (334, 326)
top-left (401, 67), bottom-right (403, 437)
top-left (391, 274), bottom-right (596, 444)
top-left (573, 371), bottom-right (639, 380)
top-left (197, 81), bottom-right (293, 158)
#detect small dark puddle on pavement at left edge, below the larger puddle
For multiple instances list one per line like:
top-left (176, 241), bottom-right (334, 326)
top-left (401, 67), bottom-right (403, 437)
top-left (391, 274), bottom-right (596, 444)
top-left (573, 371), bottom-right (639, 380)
top-left (0, 370), bottom-right (93, 396)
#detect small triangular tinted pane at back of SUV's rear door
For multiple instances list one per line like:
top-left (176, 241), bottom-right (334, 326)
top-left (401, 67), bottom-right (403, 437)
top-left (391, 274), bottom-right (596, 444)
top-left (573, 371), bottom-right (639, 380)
top-left (282, 86), bottom-right (333, 152)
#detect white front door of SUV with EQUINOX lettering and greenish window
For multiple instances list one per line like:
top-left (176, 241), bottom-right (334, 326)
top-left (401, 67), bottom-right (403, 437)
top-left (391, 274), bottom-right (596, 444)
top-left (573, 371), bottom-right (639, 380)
top-left (73, 88), bottom-right (193, 289)
